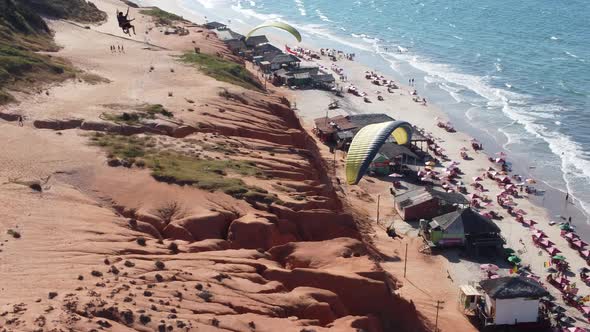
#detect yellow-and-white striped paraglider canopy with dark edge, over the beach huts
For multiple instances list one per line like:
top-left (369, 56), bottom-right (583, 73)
top-left (346, 121), bottom-right (412, 184)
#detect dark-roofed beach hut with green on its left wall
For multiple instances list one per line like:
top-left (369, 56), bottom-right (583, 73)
top-left (425, 208), bottom-right (504, 254)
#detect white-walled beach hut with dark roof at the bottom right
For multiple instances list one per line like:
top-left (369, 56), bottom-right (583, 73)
top-left (476, 276), bottom-right (549, 326)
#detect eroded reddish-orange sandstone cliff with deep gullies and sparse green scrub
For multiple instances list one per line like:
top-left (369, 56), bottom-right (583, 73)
top-left (0, 2), bottom-right (426, 331)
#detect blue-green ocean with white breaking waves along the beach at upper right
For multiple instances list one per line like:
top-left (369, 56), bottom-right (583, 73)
top-left (141, 0), bottom-right (590, 223)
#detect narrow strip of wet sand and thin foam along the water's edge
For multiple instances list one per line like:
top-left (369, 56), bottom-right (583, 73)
top-left (138, 0), bottom-right (590, 228)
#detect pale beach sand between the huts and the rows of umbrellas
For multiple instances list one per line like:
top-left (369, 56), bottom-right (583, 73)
top-left (294, 50), bottom-right (590, 323)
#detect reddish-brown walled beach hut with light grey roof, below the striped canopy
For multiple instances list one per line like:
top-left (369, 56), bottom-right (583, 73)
top-left (394, 187), bottom-right (469, 220)
